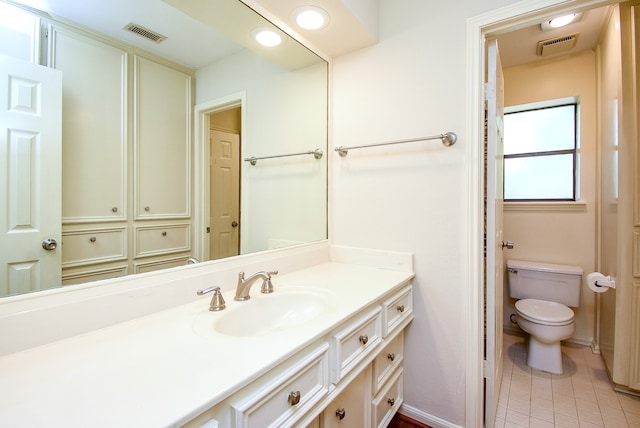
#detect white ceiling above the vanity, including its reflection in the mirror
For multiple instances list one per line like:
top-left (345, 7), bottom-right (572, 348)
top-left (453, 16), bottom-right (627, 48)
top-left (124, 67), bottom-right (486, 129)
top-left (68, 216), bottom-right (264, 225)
top-left (5, 0), bottom-right (378, 69)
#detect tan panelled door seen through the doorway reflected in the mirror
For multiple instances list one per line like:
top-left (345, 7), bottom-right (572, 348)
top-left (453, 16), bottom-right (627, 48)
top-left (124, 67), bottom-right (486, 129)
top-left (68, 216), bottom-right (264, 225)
top-left (209, 129), bottom-right (240, 260)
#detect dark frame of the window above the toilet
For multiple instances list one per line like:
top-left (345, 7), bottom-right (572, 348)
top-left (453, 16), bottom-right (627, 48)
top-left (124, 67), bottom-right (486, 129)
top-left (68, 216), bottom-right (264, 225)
top-left (502, 97), bottom-right (580, 203)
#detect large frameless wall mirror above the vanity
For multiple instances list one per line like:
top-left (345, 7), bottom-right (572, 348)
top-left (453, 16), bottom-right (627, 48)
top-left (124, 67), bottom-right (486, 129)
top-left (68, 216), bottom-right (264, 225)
top-left (0, 0), bottom-right (328, 297)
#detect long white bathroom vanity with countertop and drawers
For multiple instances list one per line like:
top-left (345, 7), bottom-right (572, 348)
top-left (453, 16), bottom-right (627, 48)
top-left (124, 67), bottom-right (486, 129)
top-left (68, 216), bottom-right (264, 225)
top-left (0, 244), bottom-right (413, 428)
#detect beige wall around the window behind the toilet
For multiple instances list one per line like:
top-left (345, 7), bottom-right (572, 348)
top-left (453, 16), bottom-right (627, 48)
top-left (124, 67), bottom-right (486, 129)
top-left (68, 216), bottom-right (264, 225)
top-left (503, 51), bottom-right (598, 344)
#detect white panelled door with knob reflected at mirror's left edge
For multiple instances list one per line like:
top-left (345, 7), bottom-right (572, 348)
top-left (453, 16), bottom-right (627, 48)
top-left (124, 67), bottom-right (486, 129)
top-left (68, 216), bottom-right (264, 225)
top-left (0, 55), bottom-right (62, 296)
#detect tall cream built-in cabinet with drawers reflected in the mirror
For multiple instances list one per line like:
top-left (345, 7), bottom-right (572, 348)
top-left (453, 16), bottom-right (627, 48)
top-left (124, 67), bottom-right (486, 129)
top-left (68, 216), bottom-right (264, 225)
top-left (47, 24), bottom-right (193, 285)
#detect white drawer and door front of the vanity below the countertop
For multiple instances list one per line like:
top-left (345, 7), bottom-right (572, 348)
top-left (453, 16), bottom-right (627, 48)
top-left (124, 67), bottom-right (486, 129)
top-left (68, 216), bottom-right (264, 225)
top-left (184, 284), bottom-right (413, 428)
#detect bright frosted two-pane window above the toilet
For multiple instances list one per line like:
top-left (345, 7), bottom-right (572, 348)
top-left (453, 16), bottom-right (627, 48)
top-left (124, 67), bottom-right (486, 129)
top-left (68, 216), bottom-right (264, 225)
top-left (504, 100), bottom-right (578, 201)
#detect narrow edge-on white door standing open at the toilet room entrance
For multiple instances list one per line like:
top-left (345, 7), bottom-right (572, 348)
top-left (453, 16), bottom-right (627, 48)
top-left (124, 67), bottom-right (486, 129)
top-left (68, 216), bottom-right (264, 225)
top-left (485, 40), bottom-right (504, 427)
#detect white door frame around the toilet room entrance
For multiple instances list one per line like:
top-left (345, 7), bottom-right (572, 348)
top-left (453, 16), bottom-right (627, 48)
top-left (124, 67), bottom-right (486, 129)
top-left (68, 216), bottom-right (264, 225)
top-left (465, 0), bottom-right (619, 427)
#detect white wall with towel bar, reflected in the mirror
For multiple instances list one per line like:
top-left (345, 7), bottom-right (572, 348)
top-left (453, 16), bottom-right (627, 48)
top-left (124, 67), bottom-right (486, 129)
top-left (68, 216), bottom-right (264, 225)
top-left (196, 51), bottom-right (327, 254)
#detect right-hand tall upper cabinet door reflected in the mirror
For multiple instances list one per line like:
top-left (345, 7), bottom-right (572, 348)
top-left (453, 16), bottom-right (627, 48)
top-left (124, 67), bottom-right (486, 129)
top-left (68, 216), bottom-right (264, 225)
top-left (133, 57), bottom-right (191, 219)
